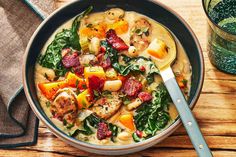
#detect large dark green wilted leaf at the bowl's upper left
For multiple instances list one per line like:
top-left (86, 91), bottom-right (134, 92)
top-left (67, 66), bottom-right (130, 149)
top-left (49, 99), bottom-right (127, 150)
top-left (38, 6), bottom-right (93, 76)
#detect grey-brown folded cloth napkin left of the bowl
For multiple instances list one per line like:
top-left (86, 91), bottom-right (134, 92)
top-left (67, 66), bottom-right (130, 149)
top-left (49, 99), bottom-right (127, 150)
top-left (0, 0), bottom-right (54, 148)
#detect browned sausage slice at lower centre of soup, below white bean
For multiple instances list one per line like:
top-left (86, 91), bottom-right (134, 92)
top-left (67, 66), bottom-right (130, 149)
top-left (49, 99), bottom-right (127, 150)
top-left (91, 92), bottom-right (122, 119)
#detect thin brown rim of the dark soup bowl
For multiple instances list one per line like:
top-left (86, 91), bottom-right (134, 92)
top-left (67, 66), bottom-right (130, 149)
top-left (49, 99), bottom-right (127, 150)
top-left (22, 0), bottom-right (205, 151)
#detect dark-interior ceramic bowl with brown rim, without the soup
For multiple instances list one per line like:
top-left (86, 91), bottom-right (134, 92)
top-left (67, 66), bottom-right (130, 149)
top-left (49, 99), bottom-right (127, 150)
top-left (23, 0), bottom-right (204, 155)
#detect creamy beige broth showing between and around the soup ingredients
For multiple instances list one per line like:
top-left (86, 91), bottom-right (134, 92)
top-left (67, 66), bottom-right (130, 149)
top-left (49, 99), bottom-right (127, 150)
top-left (35, 9), bottom-right (192, 145)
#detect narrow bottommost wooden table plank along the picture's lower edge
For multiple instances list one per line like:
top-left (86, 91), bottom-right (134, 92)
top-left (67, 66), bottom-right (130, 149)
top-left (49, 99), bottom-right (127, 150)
top-left (1, 148), bottom-right (236, 157)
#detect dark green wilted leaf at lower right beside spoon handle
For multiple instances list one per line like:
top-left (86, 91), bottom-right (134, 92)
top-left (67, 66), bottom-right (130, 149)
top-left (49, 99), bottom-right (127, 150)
top-left (133, 83), bottom-right (171, 141)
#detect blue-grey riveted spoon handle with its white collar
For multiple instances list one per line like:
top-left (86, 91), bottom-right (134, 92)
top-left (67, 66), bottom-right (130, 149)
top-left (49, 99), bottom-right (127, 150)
top-left (161, 67), bottom-right (212, 157)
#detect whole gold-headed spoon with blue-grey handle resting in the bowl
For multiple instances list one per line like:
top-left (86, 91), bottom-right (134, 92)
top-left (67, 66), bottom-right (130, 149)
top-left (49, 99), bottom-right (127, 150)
top-left (148, 24), bottom-right (212, 157)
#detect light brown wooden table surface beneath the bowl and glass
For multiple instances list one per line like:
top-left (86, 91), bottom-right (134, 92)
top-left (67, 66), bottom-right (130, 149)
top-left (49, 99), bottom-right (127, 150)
top-left (0, 0), bottom-right (236, 157)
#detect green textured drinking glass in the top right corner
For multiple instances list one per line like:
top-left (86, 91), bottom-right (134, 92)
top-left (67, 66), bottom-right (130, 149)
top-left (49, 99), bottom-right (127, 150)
top-left (203, 0), bottom-right (236, 74)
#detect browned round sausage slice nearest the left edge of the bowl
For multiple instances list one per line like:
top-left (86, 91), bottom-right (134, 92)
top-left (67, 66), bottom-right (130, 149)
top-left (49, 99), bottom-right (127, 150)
top-left (50, 88), bottom-right (78, 125)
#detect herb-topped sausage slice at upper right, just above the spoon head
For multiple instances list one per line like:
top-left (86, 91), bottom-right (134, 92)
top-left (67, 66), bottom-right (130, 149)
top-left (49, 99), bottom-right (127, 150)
top-left (130, 18), bottom-right (152, 52)
